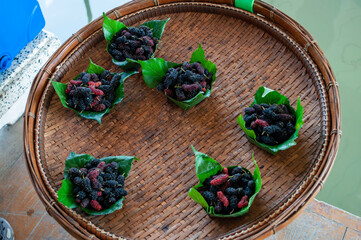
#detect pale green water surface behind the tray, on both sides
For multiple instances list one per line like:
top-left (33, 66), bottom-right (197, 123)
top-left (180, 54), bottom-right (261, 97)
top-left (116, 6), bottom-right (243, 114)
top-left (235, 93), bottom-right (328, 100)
top-left (39, 0), bottom-right (361, 216)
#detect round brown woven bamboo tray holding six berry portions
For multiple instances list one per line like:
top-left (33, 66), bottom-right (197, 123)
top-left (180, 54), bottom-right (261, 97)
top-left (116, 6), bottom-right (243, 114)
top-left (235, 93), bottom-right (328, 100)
top-left (24, 0), bottom-right (340, 239)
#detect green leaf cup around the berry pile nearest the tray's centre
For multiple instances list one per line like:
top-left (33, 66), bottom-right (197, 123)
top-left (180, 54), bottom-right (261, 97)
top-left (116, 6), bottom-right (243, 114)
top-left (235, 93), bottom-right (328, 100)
top-left (138, 44), bottom-right (217, 110)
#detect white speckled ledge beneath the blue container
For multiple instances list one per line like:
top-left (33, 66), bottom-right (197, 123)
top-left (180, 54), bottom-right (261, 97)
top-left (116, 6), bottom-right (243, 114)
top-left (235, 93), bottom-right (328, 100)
top-left (0, 30), bottom-right (60, 129)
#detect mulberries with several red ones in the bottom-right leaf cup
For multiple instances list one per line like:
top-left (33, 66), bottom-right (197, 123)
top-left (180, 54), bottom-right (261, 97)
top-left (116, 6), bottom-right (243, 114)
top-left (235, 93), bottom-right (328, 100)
top-left (200, 167), bottom-right (255, 215)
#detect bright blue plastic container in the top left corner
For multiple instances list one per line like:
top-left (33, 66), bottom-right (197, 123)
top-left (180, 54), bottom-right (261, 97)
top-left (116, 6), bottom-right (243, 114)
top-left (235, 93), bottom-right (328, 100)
top-left (0, 0), bottom-right (45, 72)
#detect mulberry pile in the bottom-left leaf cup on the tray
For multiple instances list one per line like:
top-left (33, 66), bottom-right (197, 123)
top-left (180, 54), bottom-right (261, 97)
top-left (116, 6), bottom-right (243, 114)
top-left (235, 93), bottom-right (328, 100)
top-left (69, 159), bottom-right (127, 211)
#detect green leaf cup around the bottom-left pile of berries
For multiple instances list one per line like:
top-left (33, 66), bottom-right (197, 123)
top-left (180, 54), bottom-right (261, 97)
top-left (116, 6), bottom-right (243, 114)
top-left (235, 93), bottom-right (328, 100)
top-left (58, 152), bottom-right (139, 216)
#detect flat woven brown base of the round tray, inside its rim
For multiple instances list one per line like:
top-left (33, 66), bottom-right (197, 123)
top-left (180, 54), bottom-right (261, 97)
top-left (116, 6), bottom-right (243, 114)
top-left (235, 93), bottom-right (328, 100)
top-left (38, 4), bottom-right (325, 239)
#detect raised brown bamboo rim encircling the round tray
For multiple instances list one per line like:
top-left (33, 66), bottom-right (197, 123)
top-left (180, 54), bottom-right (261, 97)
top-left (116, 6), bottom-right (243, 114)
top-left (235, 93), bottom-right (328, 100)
top-left (24, 0), bottom-right (341, 239)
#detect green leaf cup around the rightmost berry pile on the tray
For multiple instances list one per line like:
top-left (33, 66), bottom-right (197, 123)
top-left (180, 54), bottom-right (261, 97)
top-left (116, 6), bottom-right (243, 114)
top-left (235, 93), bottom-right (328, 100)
top-left (237, 87), bottom-right (303, 154)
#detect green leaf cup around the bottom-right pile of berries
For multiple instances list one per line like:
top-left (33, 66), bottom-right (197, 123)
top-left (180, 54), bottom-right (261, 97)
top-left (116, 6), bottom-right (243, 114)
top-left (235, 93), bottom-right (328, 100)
top-left (188, 150), bottom-right (262, 218)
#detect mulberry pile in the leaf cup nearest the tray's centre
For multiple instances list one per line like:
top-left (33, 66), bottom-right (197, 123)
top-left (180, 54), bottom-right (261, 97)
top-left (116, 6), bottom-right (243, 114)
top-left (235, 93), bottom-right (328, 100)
top-left (157, 62), bottom-right (213, 101)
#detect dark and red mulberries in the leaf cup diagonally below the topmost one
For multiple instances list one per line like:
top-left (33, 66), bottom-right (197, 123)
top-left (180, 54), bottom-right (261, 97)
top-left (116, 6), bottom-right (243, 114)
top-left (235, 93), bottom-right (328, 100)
top-left (65, 70), bottom-right (121, 112)
